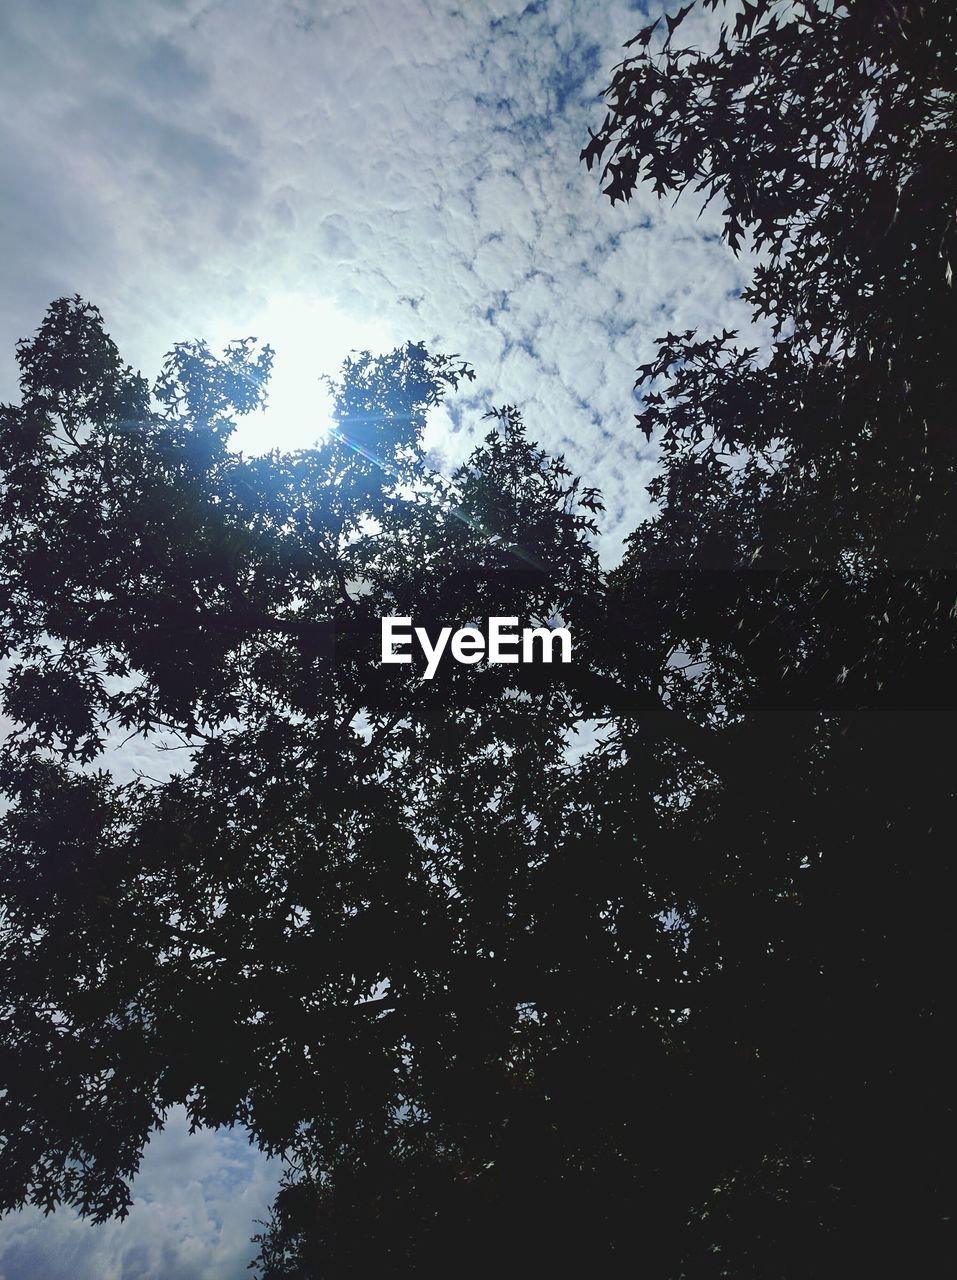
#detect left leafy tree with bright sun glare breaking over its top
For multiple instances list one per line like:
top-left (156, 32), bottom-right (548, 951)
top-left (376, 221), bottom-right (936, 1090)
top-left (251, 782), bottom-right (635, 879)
top-left (0, 300), bottom-right (609, 1192)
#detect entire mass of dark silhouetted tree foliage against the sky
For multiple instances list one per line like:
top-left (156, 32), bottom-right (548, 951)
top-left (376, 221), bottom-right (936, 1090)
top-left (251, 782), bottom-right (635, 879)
top-left (0, 0), bottom-right (957, 1280)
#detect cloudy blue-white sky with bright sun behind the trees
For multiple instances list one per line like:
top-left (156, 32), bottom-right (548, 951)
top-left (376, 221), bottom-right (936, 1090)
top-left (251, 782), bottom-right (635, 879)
top-left (0, 0), bottom-right (748, 1280)
